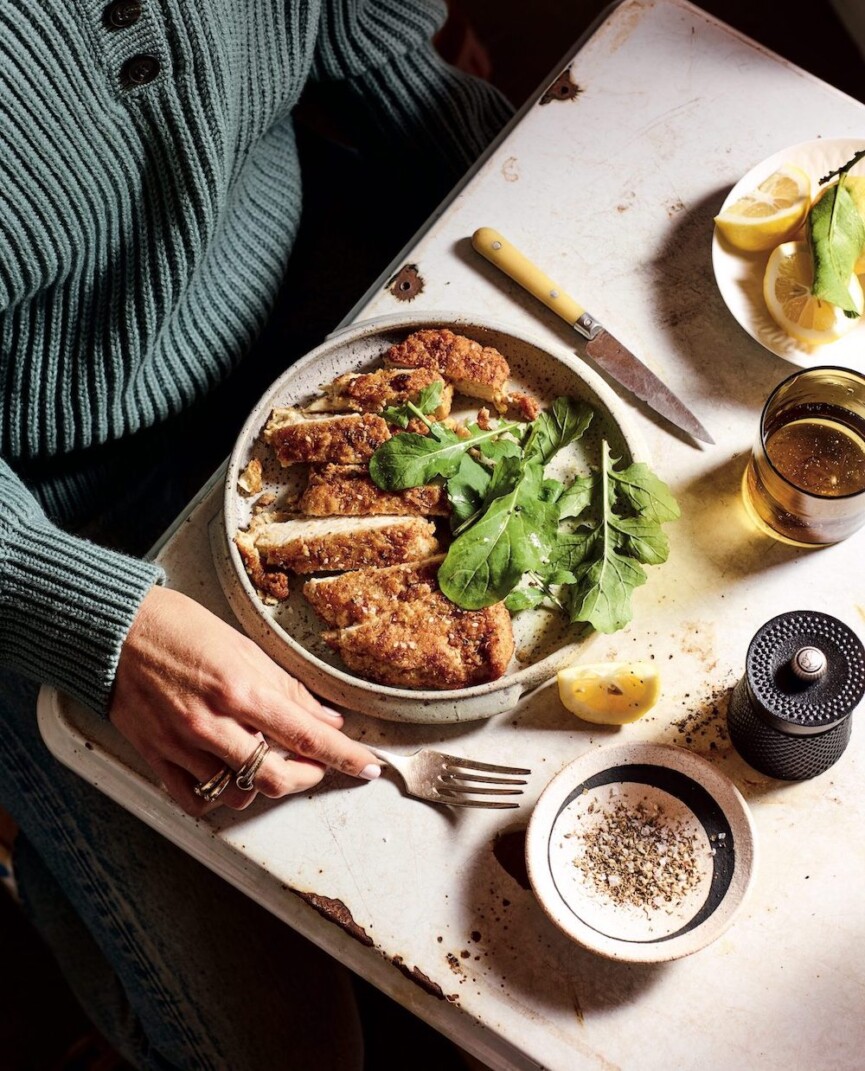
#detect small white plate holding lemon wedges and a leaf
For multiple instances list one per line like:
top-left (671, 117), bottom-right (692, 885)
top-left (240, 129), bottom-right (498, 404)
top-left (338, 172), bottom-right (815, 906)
top-left (712, 138), bottom-right (865, 372)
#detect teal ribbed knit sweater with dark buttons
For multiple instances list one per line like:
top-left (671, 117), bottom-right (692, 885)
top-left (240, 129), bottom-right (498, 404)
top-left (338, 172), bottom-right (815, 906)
top-left (0, 0), bottom-right (509, 712)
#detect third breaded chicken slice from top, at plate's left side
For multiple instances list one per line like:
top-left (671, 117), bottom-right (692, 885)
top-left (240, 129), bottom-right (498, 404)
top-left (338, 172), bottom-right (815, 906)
top-left (262, 408), bottom-right (391, 465)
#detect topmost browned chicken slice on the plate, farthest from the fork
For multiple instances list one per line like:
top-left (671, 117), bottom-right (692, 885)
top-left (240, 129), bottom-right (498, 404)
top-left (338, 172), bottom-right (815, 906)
top-left (384, 328), bottom-right (511, 412)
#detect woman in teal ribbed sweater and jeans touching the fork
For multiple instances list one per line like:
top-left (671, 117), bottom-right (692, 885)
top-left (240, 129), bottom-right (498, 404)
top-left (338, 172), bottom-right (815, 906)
top-left (0, 0), bottom-right (509, 1069)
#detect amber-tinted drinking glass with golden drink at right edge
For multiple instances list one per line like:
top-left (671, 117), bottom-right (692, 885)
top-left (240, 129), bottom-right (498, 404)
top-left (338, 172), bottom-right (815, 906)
top-left (742, 365), bottom-right (865, 546)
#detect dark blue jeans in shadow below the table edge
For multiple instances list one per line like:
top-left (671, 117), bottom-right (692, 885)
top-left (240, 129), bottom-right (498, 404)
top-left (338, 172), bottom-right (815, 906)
top-left (0, 673), bottom-right (362, 1071)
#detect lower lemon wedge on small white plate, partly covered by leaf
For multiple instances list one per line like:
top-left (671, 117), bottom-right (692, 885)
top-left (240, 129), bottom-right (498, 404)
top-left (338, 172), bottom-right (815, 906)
top-left (763, 242), bottom-right (865, 346)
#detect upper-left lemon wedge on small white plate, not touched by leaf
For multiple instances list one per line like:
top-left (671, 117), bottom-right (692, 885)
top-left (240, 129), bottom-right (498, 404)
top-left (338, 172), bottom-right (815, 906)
top-left (715, 164), bottom-right (811, 253)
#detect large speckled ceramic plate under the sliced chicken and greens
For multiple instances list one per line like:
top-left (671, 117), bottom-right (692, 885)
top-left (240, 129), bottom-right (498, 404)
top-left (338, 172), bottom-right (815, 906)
top-left (211, 313), bottom-right (648, 722)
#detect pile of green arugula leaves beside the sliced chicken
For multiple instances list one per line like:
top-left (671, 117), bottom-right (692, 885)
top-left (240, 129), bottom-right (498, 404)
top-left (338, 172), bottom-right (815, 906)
top-left (361, 397), bottom-right (679, 632)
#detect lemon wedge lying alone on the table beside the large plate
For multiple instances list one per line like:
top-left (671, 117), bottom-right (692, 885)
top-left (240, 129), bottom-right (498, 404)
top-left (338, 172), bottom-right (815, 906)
top-left (558, 662), bottom-right (661, 725)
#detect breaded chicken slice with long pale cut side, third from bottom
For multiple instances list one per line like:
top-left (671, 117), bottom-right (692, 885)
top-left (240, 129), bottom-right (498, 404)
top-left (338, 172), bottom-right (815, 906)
top-left (236, 514), bottom-right (440, 575)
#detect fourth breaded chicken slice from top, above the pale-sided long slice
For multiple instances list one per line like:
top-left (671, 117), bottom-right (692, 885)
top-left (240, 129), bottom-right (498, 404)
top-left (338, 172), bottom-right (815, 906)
top-left (298, 465), bottom-right (451, 517)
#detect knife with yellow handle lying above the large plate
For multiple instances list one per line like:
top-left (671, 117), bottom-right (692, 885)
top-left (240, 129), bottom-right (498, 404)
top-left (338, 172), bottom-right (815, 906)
top-left (471, 227), bottom-right (715, 444)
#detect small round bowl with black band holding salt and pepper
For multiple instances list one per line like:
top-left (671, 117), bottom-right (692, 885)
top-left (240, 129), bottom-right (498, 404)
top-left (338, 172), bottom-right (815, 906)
top-left (526, 743), bottom-right (755, 963)
